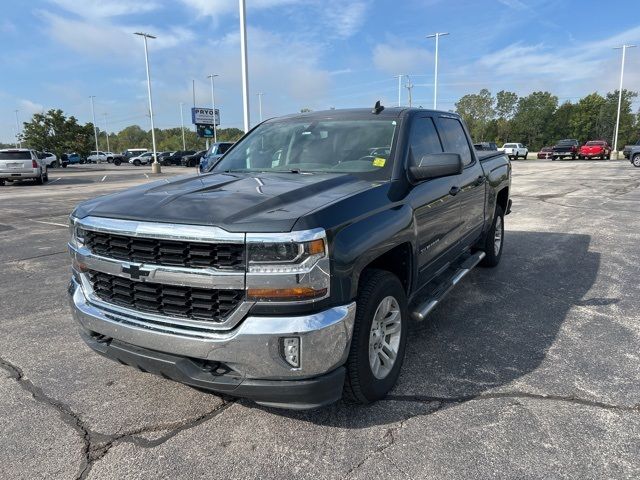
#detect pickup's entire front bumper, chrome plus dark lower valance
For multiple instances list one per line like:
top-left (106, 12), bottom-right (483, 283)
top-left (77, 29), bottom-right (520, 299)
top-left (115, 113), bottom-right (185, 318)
top-left (69, 280), bottom-right (355, 408)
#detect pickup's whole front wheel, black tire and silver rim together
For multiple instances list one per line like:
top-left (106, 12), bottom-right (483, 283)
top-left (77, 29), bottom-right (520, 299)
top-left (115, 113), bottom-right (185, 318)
top-left (343, 269), bottom-right (409, 404)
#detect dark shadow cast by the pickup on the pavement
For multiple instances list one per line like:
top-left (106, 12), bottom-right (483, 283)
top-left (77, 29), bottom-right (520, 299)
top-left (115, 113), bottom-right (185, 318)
top-left (278, 231), bottom-right (604, 428)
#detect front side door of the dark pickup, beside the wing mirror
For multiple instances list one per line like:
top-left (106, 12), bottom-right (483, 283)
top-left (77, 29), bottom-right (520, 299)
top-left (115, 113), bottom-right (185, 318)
top-left (408, 116), bottom-right (460, 286)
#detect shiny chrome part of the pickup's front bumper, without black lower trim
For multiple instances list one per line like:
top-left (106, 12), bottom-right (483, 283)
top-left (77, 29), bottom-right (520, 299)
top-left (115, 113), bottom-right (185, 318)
top-left (69, 280), bottom-right (356, 380)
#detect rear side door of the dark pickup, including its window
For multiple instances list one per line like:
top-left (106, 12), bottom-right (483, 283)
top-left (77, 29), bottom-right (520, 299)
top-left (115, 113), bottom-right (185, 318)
top-left (437, 115), bottom-right (486, 250)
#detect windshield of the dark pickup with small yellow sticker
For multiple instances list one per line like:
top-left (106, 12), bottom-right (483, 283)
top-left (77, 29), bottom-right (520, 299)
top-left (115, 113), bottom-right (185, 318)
top-left (214, 118), bottom-right (396, 180)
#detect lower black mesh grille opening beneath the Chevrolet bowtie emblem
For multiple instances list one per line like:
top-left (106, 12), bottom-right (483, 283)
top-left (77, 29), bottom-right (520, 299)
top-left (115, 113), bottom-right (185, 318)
top-left (89, 271), bottom-right (244, 322)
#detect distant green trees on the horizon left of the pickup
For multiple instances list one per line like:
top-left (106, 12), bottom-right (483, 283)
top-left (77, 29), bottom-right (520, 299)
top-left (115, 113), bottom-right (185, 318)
top-left (13, 109), bottom-right (243, 156)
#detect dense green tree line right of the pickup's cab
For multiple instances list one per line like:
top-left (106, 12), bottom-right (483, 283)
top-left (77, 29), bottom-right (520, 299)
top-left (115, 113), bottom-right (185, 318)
top-left (455, 88), bottom-right (640, 151)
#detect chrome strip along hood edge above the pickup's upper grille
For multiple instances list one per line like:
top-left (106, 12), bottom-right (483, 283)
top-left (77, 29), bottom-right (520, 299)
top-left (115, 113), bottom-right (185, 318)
top-left (70, 216), bottom-right (245, 244)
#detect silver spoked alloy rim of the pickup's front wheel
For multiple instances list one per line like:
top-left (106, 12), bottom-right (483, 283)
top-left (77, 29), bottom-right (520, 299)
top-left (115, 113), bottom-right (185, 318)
top-left (369, 296), bottom-right (402, 380)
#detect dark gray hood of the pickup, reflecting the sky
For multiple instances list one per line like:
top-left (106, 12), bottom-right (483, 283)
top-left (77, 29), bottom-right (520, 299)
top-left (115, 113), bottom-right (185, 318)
top-left (73, 173), bottom-right (375, 232)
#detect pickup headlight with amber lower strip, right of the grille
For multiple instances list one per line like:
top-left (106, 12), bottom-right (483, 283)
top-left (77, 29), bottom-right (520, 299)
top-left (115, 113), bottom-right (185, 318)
top-left (247, 229), bottom-right (330, 302)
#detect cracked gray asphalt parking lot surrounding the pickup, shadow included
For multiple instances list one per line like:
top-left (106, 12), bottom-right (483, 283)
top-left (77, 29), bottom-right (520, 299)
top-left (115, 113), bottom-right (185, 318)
top-left (0, 161), bottom-right (640, 479)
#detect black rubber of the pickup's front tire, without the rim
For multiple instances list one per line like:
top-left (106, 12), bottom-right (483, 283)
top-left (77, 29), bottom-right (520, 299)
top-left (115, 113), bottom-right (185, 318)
top-left (343, 269), bottom-right (409, 404)
